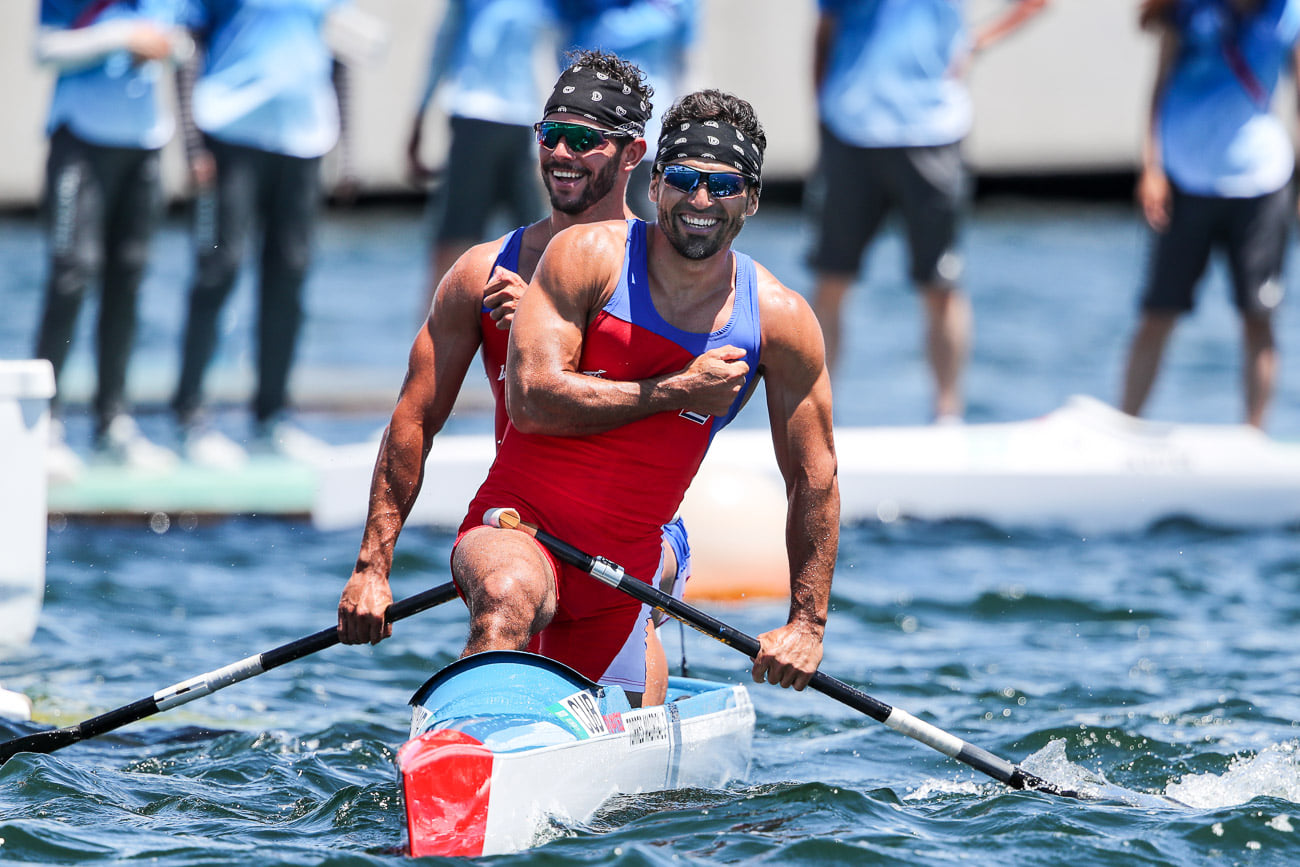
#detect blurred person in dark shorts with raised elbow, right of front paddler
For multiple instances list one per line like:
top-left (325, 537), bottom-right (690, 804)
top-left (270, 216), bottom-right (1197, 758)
top-left (810, 0), bottom-right (1047, 421)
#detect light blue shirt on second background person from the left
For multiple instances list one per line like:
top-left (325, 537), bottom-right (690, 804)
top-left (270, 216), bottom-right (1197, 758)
top-left (191, 0), bottom-right (346, 159)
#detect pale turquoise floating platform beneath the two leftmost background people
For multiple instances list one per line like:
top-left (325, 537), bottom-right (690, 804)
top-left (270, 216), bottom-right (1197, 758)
top-left (48, 458), bottom-right (319, 519)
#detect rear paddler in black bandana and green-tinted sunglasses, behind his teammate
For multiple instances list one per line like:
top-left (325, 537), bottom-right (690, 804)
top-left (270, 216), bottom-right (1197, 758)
top-left (339, 51), bottom-right (689, 707)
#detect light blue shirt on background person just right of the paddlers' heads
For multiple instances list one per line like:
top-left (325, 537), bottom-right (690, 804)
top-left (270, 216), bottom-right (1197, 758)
top-left (818, 0), bottom-right (971, 147)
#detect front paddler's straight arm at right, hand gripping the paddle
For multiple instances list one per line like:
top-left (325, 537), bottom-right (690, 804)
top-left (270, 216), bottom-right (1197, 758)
top-left (753, 272), bottom-right (840, 689)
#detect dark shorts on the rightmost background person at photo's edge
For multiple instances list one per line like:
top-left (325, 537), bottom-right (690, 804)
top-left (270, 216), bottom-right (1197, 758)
top-left (1141, 185), bottom-right (1292, 316)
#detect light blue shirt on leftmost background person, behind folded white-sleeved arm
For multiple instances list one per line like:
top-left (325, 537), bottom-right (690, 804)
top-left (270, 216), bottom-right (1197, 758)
top-left (40, 0), bottom-right (183, 151)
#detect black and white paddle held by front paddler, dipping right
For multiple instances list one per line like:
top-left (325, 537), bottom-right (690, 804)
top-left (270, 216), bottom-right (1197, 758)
top-left (484, 508), bottom-right (1091, 799)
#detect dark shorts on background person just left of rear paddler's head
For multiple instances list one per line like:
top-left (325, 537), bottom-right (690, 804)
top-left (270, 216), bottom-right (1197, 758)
top-left (433, 117), bottom-right (543, 243)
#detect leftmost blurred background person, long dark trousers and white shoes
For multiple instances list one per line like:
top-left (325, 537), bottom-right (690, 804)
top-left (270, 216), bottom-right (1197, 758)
top-left (35, 0), bottom-right (194, 476)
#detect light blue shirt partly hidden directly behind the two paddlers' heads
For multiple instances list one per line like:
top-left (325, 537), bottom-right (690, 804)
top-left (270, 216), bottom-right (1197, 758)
top-left (562, 0), bottom-right (699, 160)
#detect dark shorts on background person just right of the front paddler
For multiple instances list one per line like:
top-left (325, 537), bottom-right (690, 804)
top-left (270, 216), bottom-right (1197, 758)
top-left (809, 126), bottom-right (967, 286)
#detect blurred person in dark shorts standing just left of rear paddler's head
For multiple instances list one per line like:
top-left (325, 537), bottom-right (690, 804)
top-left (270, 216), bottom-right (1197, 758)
top-left (407, 0), bottom-right (554, 320)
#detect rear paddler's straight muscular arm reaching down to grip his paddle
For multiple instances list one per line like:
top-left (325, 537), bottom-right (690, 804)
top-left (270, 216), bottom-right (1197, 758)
top-left (338, 244), bottom-right (491, 643)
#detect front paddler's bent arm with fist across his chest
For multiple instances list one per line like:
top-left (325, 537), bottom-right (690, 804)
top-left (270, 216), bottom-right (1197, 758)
top-left (506, 221), bottom-right (749, 437)
